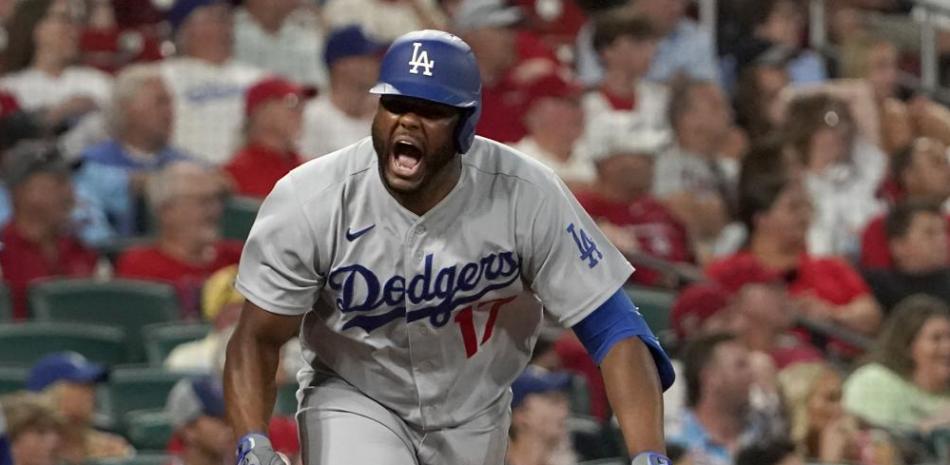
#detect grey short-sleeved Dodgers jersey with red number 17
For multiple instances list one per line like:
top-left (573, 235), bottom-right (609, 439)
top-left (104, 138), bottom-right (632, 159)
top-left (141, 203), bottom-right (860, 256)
top-left (237, 137), bottom-right (633, 429)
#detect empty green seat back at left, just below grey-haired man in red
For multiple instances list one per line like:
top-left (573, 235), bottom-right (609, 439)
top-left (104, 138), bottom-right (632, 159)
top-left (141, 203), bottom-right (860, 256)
top-left (29, 279), bottom-right (180, 362)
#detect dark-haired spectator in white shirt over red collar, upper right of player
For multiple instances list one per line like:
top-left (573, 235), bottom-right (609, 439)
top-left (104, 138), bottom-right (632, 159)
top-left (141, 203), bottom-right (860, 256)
top-left (583, 8), bottom-right (669, 128)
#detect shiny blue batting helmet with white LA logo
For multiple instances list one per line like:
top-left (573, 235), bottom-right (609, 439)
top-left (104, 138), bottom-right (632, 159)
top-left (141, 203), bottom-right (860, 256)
top-left (370, 30), bottom-right (482, 153)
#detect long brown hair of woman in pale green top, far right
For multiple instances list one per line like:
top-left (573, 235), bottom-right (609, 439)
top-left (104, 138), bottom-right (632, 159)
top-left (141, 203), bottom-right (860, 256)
top-left (869, 294), bottom-right (950, 378)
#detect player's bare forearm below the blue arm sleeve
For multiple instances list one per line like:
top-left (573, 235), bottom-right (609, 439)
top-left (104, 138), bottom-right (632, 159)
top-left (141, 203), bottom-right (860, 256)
top-left (600, 337), bottom-right (666, 456)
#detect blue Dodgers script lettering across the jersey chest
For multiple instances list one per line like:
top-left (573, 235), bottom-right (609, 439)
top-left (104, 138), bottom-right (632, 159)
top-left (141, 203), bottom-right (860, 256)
top-left (327, 252), bottom-right (521, 333)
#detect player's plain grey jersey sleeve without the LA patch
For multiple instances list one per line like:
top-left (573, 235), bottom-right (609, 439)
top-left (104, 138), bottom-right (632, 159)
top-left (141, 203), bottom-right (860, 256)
top-left (235, 176), bottom-right (326, 315)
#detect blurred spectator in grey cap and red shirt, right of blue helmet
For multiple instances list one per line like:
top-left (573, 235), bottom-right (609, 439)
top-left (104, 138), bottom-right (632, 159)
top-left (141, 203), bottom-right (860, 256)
top-left (453, 0), bottom-right (557, 142)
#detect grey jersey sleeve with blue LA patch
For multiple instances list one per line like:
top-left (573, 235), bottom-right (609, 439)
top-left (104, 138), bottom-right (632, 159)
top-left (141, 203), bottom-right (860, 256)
top-left (522, 175), bottom-right (633, 326)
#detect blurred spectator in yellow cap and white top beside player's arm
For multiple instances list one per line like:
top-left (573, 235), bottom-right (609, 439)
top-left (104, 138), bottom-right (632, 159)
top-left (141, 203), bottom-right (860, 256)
top-left (165, 265), bottom-right (244, 374)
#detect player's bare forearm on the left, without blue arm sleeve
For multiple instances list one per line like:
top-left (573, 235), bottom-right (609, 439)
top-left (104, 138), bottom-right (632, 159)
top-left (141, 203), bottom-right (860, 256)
top-left (224, 331), bottom-right (280, 437)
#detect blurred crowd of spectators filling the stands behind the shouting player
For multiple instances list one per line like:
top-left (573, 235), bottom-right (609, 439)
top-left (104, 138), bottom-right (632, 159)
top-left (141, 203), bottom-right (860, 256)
top-left (0, 0), bottom-right (950, 465)
